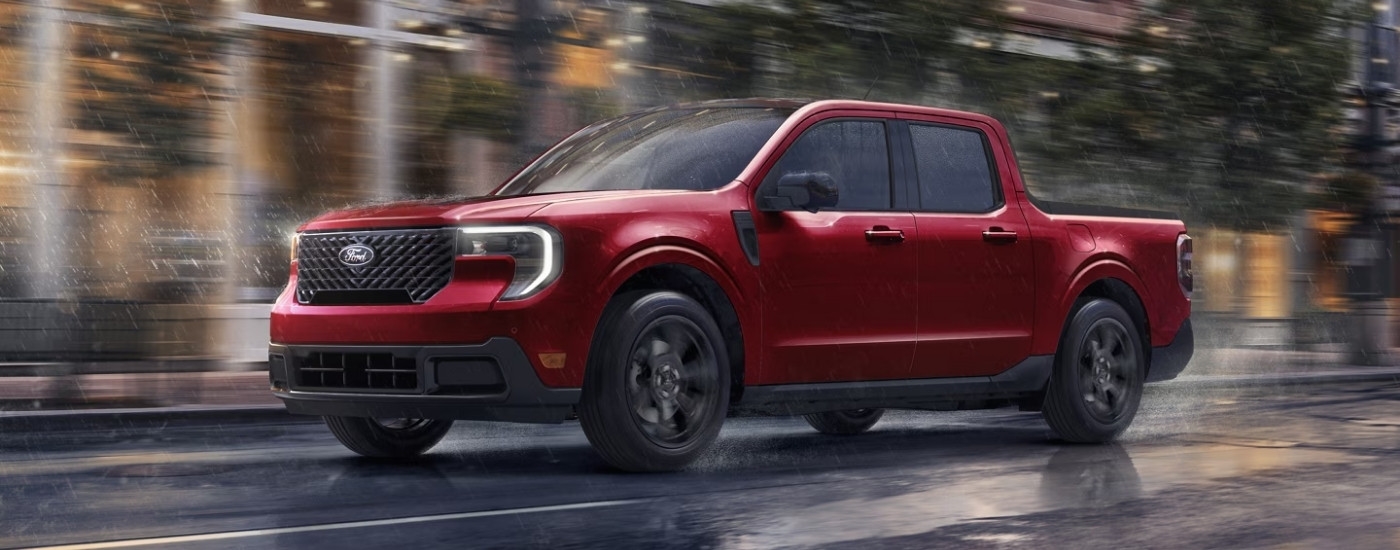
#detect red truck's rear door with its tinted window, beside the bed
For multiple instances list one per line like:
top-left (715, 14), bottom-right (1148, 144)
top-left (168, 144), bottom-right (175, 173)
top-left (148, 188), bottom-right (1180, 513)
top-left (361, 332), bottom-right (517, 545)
top-left (897, 116), bottom-right (1035, 378)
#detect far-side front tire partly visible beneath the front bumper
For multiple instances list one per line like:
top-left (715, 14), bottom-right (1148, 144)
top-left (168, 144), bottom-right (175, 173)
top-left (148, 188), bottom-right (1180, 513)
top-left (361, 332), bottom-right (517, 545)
top-left (325, 416), bottom-right (452, 459)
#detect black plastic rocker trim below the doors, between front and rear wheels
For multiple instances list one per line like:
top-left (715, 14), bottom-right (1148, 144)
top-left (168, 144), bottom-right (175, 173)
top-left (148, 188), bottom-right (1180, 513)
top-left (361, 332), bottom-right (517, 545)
top-left (734, 355), bottom-right (1054, 414)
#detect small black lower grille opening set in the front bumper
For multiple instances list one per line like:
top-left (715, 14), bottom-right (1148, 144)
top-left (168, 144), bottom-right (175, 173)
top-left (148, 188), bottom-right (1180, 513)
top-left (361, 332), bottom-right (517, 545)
top-left (293, 351), bottom-right (419, 393)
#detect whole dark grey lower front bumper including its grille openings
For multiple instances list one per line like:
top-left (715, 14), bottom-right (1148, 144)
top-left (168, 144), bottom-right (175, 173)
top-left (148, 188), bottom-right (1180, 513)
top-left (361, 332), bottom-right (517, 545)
top-left (269, 337), bottom-right (580, 423)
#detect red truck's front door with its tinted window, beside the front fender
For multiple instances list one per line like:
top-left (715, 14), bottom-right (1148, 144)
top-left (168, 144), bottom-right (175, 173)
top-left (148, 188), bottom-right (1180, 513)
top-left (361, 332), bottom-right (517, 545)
top-left (755, 118), bottom-right (918, 383)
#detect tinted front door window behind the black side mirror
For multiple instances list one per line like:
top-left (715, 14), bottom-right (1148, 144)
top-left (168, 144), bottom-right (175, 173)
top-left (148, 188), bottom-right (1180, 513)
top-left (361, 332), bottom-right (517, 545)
top-left (763, 120), bottom-right (893, 210)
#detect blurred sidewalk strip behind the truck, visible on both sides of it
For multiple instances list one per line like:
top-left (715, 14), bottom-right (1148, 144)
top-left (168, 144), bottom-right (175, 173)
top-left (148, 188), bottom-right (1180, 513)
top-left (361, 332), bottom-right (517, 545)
top-left (0, 348), bottom-right (1400, 421)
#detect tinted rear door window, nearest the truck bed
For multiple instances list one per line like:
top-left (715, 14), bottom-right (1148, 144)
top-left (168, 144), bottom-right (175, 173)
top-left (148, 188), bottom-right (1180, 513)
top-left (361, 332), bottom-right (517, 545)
top-left (909, 125), bottom-right (1001, 213)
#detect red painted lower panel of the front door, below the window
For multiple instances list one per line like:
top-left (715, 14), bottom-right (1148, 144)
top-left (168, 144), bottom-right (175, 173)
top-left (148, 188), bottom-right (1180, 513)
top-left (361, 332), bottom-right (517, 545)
top-left (752, 211), bottom-right (918, 383)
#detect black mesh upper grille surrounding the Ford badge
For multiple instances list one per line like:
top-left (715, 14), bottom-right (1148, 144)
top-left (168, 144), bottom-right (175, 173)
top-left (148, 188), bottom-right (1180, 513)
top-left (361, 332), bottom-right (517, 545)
top-left (297, 228), bottom-right (456, 305)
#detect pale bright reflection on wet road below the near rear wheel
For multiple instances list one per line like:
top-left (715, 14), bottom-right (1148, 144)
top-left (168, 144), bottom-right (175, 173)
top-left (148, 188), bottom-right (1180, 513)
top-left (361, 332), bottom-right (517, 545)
top-left (731, 445), bottom-right (1357, 549)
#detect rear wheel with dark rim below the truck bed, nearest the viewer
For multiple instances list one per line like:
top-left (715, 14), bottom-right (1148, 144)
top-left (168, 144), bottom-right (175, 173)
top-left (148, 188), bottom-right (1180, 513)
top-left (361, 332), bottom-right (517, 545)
top-left (1042, 298), bottom-right (1147, 444)
